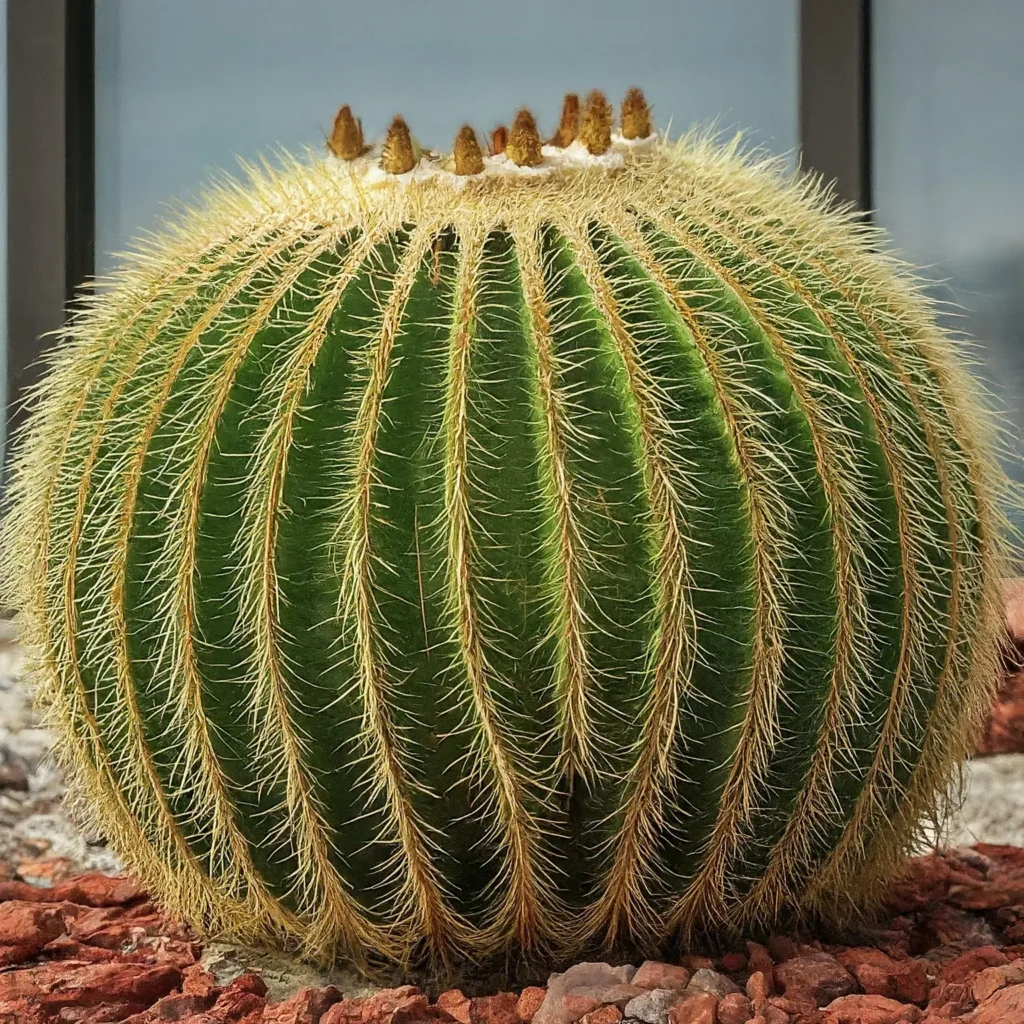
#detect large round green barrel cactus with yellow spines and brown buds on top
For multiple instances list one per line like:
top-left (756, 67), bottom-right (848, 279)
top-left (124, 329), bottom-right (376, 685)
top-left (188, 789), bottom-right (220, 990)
top-left (4, 90), bottom-right (1002, 967)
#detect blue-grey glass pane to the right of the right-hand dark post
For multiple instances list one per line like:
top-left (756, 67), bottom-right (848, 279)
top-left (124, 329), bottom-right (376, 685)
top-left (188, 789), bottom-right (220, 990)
top-left (872, 0), bottom-right (1024, 499)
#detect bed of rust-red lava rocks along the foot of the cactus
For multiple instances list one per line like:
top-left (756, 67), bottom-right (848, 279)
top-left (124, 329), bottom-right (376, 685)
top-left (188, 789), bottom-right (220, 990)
top-left (18, 846), bottom-right (1024, 1024)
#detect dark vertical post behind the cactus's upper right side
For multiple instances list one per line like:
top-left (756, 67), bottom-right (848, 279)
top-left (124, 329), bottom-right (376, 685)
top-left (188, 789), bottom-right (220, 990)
top-left (800, 0), bottom-right (871, 210)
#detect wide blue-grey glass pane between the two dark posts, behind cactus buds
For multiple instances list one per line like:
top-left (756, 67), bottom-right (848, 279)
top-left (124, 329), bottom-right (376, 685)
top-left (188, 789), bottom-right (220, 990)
top-left (96, 0), bottom-right (798, 269)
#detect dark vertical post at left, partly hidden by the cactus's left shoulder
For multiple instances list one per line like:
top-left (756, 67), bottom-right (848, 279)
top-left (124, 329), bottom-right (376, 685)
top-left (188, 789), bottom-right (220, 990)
top-left (5, 0), bottom-right (94, 456)
